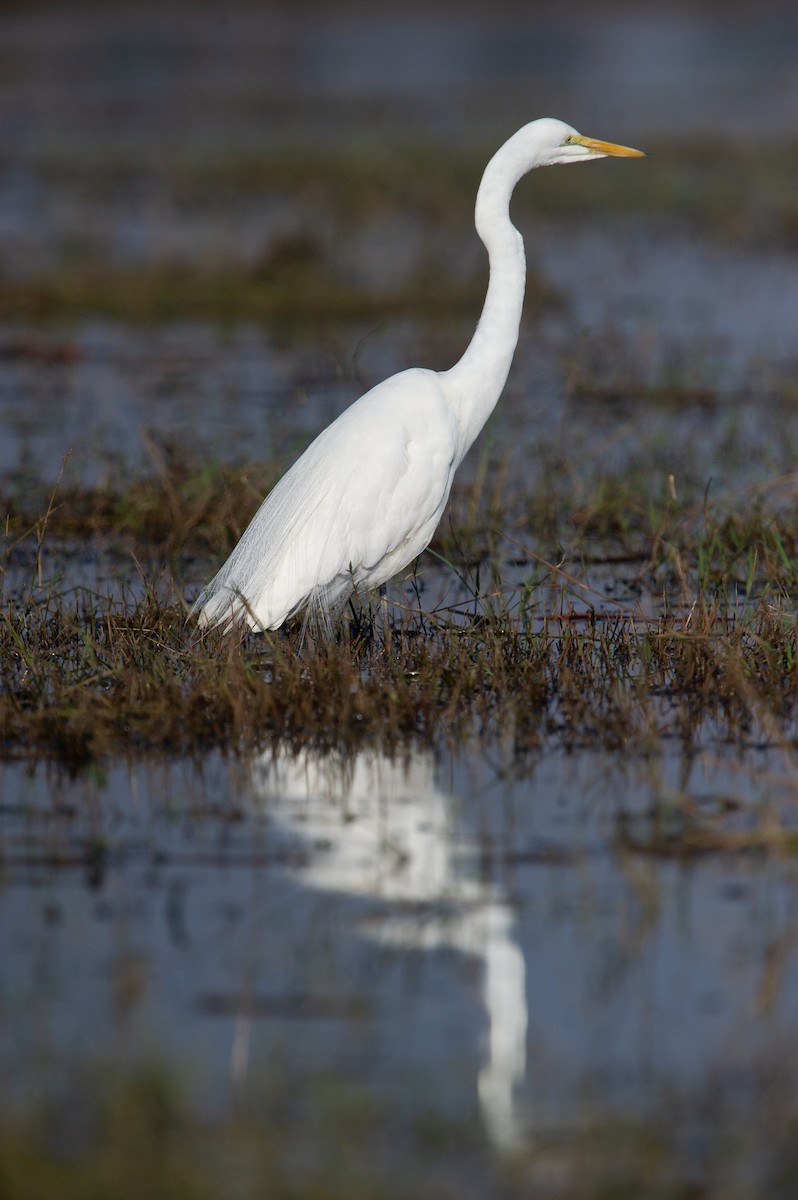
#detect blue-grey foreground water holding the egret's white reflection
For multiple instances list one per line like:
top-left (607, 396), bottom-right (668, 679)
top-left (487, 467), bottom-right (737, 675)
top-left (0, 750), bottom-right (798, 1146)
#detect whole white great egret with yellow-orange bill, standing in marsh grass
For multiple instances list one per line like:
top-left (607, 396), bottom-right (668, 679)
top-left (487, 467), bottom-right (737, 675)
top-left (192, 118), bottom-right (643, 631)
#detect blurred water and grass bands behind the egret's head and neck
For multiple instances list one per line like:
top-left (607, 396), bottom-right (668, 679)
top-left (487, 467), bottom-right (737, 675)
top-left (0, 0), bottom-right (798, 482)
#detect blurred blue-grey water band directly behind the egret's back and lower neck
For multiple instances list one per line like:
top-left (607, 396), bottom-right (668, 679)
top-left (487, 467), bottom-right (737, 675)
top-left (6, 213), bottom-right (798, 490)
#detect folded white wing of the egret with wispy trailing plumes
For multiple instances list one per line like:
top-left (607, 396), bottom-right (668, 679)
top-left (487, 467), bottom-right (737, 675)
top-left (194, 370), bottom-right (456, 628)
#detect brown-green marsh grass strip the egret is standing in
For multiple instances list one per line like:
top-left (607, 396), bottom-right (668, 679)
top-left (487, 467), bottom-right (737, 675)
top-left (0, 451), bottom-right (798, 769)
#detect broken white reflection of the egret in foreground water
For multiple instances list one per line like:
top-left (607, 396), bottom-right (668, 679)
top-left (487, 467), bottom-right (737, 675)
top-left (249, 751), bottom-right (527, 1146)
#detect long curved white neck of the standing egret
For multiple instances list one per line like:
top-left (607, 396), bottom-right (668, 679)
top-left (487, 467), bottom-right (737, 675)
top-left (442, 134), bottom-right (535, 460)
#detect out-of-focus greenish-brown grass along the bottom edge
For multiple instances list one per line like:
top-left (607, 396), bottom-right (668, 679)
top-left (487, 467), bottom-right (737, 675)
top-left (0, 1061), bottom-right (798, 1200)
